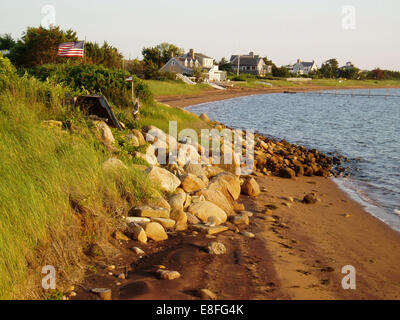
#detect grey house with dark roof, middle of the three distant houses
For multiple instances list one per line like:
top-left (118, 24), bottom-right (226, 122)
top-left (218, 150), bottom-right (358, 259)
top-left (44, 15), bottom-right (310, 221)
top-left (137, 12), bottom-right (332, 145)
top-left (230, 52), bottom-right (272, 76)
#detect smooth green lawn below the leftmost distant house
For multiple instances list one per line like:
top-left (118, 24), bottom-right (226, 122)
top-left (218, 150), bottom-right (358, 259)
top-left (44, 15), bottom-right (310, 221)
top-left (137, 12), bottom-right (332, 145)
top-left (145, 80), bottom-right (211, 96)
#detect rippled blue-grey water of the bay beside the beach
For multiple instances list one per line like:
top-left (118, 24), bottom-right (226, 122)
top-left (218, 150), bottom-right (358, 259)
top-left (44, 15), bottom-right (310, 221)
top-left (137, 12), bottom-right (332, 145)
top-left (189, 89), bottom-right (400, 231)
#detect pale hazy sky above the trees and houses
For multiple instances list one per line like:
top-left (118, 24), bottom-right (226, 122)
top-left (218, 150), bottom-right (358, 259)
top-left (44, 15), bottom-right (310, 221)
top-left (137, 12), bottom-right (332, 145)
top-left (0, 0), bottom-right (400, 71)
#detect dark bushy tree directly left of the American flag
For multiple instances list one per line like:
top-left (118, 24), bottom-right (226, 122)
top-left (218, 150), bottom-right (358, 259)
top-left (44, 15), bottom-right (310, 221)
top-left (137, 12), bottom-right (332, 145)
top-left (10, 27), bottom-right (78, 67)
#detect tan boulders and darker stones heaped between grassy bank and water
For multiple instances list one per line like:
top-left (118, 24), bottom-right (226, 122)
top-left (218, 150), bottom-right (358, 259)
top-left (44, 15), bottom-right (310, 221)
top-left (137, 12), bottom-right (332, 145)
top-left (70, 114), bottom-right (352, 299)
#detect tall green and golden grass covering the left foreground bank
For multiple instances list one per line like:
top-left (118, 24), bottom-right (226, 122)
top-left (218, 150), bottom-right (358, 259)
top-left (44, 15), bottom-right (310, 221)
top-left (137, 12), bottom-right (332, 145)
top-left (0, 79), bottom-right (157, 299)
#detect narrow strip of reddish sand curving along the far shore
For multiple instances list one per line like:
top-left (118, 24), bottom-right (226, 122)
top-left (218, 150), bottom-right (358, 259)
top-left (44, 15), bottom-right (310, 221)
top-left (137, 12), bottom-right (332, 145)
top-left (155, 86), bottom-right (400, 108)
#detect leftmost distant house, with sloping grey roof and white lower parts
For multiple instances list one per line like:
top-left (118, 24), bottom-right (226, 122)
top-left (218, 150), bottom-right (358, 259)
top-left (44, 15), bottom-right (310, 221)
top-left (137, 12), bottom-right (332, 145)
top-left (160, 49), bottom-right (227, 81)
